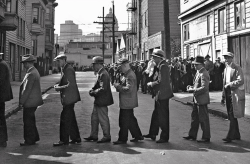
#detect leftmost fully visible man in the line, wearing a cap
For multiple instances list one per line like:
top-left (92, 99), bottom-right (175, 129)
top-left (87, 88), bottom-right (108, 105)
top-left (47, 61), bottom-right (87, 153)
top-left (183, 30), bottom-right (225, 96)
top-left (19, 54), bottom-right (43, 146)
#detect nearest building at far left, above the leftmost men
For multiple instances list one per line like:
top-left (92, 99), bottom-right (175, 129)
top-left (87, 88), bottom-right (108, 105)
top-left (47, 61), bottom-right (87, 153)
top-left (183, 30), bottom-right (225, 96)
top-left (0, 0), bottom-right (32, 81)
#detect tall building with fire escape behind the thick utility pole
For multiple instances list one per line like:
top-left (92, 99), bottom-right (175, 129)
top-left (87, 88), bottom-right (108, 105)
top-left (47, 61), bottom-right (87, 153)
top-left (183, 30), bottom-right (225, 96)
top-left (127, 0), bottom-right (181, 60)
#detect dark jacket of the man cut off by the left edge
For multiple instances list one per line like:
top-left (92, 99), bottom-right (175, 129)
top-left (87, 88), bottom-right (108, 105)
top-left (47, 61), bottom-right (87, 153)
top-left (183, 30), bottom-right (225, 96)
top-left (0, 60), bottom-right (13, 102)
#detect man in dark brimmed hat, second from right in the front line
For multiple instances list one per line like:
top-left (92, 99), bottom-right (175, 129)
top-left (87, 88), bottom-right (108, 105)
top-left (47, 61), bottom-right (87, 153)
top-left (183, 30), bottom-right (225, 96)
top-left (183, 56), bottom-right (211, 143)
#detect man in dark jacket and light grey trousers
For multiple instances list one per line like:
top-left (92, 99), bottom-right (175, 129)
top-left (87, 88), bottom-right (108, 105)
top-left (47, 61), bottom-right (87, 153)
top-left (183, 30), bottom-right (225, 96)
top-left (84, 56), bottom-right (114, 143)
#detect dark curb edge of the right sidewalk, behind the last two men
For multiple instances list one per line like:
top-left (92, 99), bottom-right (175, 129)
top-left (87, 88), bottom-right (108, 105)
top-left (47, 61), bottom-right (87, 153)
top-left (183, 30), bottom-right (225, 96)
top-left (172, 98), bottom-right (250, 122)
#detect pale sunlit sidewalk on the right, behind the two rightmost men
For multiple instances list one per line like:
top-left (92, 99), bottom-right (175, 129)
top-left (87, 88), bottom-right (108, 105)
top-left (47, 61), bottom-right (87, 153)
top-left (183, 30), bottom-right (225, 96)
top-left (172, 91), bottom-right (250, 119)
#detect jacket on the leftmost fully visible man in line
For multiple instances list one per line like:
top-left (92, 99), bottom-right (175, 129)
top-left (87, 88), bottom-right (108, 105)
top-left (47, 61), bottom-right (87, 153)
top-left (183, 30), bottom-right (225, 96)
top-left (19, 67), bottom-right (43, 108)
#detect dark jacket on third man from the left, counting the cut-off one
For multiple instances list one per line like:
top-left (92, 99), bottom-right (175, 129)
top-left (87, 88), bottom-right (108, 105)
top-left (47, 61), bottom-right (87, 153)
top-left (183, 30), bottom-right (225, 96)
top-left (59, 63), bottom-right (81, 105)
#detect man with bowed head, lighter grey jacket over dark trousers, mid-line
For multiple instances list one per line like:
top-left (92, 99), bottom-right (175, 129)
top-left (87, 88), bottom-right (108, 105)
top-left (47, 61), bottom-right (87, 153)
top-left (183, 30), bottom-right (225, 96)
top-left (113, 58), bottom-right (144, 145)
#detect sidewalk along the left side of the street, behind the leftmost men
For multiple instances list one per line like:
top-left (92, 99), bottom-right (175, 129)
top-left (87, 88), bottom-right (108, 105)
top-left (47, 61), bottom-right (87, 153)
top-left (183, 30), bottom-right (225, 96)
top-left (5, 74), bottom-right (61, 117)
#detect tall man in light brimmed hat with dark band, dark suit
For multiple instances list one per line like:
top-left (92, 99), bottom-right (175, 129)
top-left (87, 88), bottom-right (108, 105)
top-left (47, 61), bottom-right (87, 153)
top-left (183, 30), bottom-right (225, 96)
top-left (144, 49), bottom-right (173, 143)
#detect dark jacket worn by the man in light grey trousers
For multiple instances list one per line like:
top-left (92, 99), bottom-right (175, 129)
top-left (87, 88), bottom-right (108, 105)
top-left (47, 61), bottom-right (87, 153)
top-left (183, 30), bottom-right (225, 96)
top-left (92, 68), bottom-right (114, 106)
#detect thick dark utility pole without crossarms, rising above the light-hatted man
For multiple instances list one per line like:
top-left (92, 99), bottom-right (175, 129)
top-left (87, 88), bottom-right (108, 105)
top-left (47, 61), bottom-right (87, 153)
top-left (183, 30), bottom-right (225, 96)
top-left (163, 0), bottom-right (171, 59)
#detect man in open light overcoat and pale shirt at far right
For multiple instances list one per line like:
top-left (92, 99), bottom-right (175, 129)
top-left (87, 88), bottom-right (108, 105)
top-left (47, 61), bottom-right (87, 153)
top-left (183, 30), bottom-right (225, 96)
top-left (221, 52), bottom-right (246, 143)
